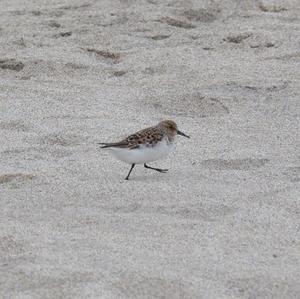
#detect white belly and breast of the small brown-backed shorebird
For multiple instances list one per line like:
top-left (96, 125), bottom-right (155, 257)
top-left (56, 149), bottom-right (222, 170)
top-left (108, 139), bottom-right (173, 164)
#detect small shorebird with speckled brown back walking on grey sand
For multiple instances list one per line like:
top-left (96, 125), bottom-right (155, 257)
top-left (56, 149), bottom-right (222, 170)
top-left (99, 120), bottom-right (190, 180)
